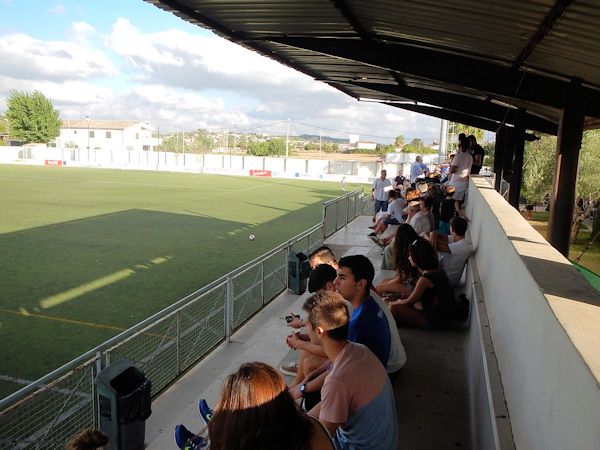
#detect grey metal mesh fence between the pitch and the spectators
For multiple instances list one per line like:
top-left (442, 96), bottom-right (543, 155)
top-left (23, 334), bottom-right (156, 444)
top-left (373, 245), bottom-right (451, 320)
top-left (0, 190), bottom-right (369, 449)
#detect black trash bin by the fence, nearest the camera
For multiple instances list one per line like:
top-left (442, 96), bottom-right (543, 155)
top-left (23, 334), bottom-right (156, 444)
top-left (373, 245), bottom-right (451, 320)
top-left (94, 359), bottom-right (152, 450)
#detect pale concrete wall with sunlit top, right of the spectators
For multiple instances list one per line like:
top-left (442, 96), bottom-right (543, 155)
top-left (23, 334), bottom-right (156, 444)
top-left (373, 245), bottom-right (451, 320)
top-left (467, 177), bottom-right (600, 450)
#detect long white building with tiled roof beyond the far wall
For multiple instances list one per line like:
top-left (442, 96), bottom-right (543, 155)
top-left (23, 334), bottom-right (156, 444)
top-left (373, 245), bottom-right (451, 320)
top-left (55, 120), bottom-right (161, 152)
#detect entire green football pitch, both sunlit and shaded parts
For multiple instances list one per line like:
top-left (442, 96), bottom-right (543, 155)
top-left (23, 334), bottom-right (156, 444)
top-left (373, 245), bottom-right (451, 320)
top-left (0, 165), bottom-right (354, 398)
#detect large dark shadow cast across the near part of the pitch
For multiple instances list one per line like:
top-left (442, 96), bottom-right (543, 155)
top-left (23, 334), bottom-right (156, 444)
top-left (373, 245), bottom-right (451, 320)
top-left (0, 202), bottom-right (322, 394)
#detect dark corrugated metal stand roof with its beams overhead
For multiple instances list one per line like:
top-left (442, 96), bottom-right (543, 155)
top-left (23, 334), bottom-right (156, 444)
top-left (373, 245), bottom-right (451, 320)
top-left (146, 0), bottom-right (600, 134)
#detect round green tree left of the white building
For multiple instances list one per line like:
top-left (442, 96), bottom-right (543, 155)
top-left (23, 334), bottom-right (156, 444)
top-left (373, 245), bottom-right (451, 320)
top-left (6, 90), bottom-right (61, 144)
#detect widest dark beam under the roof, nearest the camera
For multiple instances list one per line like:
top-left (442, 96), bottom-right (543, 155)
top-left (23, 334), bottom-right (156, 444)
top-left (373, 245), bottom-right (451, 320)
top-left (270, 37), bottom-right (600, 117)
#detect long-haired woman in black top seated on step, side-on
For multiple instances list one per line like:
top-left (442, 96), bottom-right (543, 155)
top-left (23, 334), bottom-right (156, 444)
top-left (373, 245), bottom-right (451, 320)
top-left (389, 238), bottom-right (458, 329)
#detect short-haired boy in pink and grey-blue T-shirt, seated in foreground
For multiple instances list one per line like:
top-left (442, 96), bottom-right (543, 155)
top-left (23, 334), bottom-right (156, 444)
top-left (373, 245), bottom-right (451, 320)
top-left (304, 290), bottom-right (398, 450)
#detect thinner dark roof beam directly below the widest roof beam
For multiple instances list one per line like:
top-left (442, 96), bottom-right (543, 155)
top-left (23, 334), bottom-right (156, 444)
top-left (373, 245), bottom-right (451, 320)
top-left (348, 81), bottom-right (558, 136)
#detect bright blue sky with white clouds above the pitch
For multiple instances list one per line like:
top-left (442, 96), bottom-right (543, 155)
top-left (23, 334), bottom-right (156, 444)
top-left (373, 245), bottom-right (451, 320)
top-left (0, 0), bottom-right (440, 143)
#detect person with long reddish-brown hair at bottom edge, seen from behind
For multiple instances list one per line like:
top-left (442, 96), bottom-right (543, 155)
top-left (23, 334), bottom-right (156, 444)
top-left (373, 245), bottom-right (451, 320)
top-left (175, 362), bottom-right (335, 450)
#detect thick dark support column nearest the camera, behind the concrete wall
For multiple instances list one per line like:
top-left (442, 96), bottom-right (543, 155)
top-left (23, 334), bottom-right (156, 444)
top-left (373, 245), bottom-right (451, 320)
top-left (548, 80), bottom-right (585, 257)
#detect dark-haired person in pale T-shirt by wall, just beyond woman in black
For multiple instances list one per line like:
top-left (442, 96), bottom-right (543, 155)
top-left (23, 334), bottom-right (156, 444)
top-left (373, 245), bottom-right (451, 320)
top-left (429, 217), bottom-right (471, 286)
